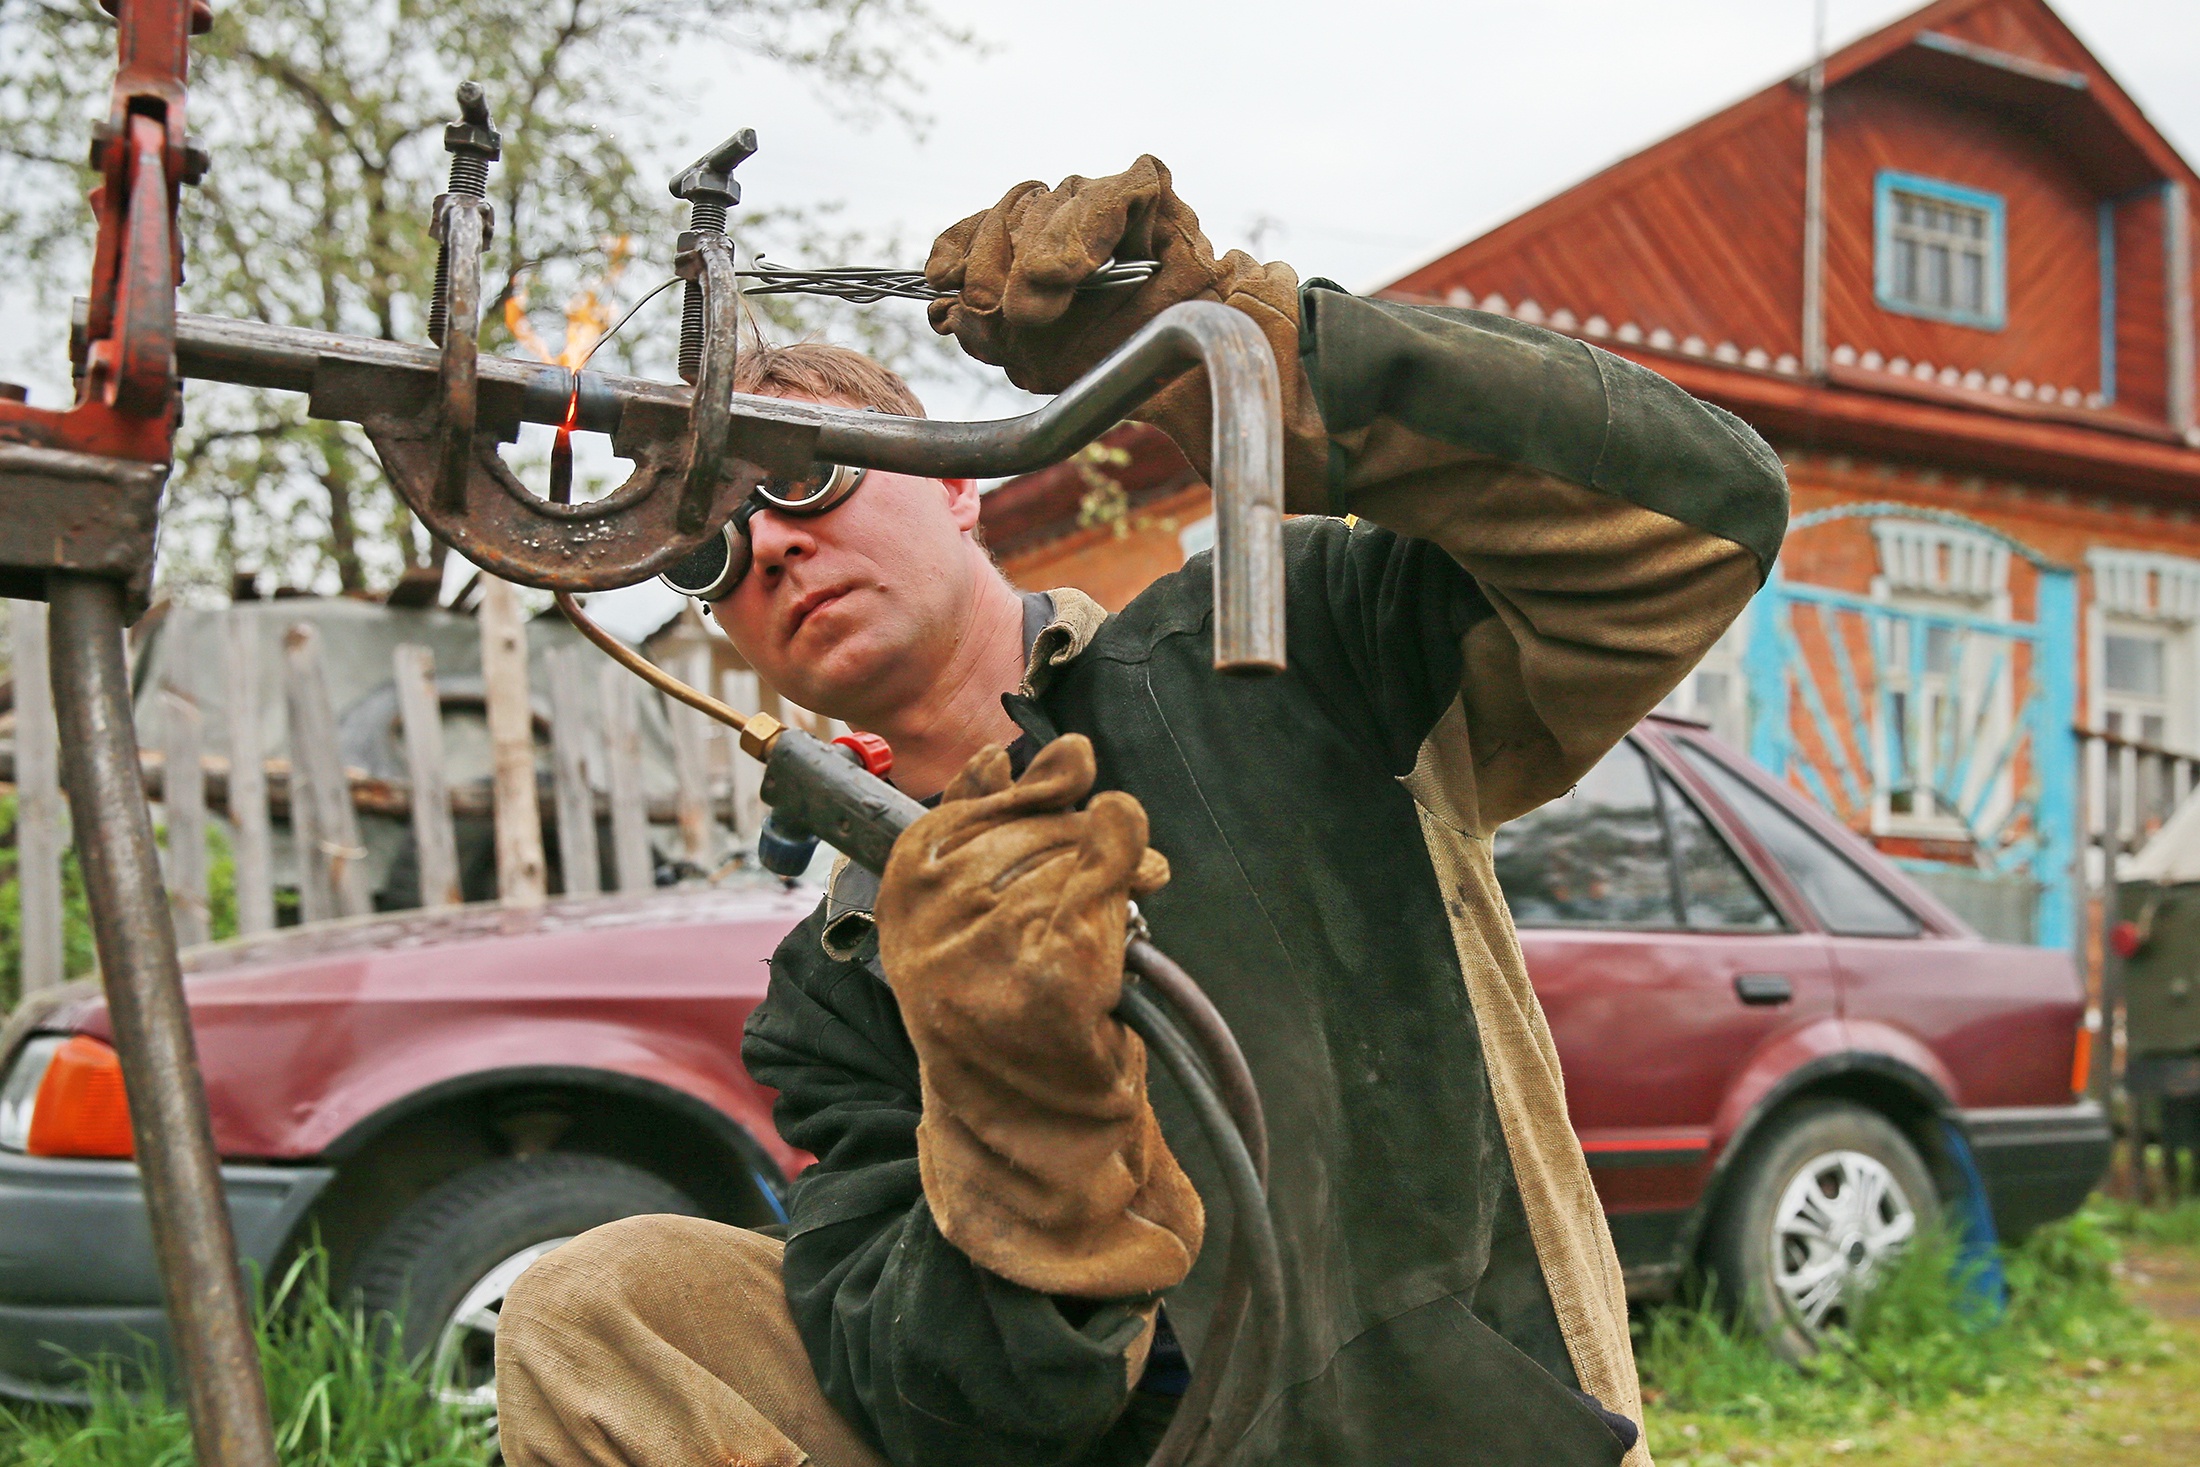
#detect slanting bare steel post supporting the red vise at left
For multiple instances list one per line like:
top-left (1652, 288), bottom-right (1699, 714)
top-left (46, 572), bottom-right (275, 1467)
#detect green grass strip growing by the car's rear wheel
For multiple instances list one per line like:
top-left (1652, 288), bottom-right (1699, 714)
top-left (1637, 1205), bottom-right (2167, 1460)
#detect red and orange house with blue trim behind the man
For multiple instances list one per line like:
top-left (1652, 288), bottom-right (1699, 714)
top-left (988, 0), bottom-right (2200, 944)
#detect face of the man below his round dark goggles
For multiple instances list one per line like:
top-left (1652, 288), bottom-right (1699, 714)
top-left (711, 413), bottom-right (986, 721)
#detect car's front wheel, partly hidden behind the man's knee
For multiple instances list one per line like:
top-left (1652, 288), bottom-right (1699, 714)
top-left (352, 1152), bottom-right (697, 1412)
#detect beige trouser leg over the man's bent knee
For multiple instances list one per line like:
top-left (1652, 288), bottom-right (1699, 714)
top-left (497, 1216), bottom-right (884, 1467)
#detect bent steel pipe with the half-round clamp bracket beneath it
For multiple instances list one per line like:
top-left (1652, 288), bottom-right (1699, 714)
top-left (176, 301), bottom-right (1285, 671)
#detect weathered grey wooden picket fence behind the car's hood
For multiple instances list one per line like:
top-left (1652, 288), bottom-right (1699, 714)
top-left (0, 578), bottom-right (800, 992)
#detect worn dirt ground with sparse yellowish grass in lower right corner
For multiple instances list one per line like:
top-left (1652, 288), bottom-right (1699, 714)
top-left (1650, 1245), bottom-right (2200, 1467)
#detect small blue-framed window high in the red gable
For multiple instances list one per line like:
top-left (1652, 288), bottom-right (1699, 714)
top-left (1877, 174), bottom-right (2002, 330)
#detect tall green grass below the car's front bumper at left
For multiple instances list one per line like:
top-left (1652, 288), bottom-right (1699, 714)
top-left (0, 1251), bottom-right (491, 1467)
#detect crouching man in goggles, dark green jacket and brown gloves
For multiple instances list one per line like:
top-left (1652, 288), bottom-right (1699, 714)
top-left (497, 158), bottom-right (1786, 1467)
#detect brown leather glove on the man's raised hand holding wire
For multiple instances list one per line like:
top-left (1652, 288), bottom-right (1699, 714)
top-left (924, 154), bottom-right (1329, 512)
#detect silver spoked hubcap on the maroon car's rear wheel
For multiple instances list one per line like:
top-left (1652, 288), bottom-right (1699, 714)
top-left (1771, 1150), bottom-right (1918, 1335)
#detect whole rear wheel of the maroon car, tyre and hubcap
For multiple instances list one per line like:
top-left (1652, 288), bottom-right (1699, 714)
top-left (1705, 1100), bottom-right (1940, 1359)
